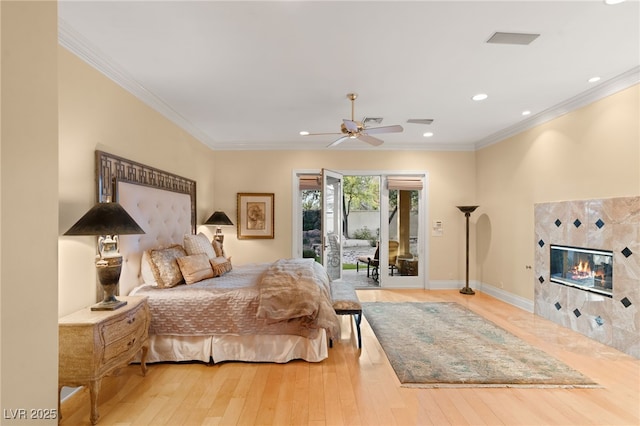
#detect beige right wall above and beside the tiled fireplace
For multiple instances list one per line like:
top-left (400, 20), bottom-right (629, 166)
top-left (476, 85), bottom-right (640, 300)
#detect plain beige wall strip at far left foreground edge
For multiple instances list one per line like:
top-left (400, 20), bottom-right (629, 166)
top-left (0, 1), bottom-right (58, 424)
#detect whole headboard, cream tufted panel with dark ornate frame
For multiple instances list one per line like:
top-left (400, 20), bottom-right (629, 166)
top-left (96, 151), bottom-right (196, 300)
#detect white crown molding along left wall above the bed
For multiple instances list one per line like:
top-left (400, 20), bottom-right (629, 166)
top-left (58, 17), bottom-right (214, 148)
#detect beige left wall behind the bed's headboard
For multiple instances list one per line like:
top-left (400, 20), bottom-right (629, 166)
top-left (58, 47), bottom-right (215, 316)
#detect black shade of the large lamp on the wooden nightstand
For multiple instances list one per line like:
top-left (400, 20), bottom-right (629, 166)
top-left (64, 203), bottom-right (145, 235)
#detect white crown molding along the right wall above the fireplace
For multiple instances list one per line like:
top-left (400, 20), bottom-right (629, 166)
top-left (474, 66), bottom-right (640, 150)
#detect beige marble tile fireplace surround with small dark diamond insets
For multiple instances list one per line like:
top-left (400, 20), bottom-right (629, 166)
top-left (534, 197), bottom-right (640, 358)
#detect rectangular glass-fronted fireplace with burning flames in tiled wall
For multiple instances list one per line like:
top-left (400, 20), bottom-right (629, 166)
top-left (550, 244), bottom-right (613, 297)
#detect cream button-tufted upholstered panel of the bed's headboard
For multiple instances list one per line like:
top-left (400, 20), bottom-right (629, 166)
top-left (116, 182), bottom-right (192, 295)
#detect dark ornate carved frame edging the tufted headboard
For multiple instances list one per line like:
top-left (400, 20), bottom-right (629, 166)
top-left (96, 150), bottom-right (196, 232)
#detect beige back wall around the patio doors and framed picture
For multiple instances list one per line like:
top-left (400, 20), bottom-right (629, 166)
top-left (214, 150), bottom-right (475, 280)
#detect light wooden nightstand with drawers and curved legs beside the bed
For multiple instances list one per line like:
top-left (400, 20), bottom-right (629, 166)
top-left (58, 296), bottom-right (150, 424)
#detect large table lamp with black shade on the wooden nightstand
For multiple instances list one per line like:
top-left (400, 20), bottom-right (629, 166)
top-left (64, 202), bottom-right (144, 311)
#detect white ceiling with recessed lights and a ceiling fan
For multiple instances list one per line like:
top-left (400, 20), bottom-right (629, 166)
top-left (59, 0), bottom-right (640, 150)
